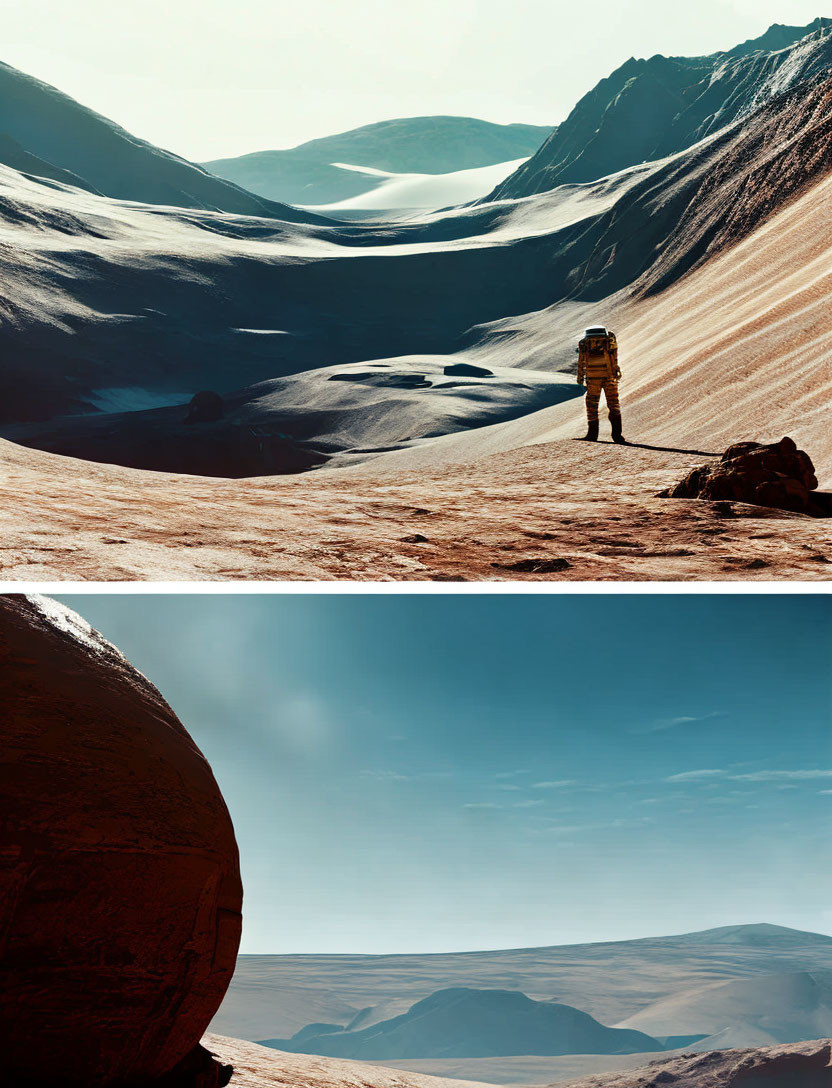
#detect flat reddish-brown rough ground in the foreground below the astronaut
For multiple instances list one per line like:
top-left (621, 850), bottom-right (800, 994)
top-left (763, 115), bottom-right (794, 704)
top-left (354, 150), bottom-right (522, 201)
top-left (0, 438), bottom-right (832, 581)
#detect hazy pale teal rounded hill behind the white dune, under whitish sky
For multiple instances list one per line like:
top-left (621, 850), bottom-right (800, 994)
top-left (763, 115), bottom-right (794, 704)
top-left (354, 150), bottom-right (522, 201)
top-left (203, 116), bottom-right (551, 205)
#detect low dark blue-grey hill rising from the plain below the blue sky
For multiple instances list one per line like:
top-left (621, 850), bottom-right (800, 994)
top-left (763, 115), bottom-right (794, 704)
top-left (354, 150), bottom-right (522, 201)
top-left (256, 987), bottom-right (661, 1061)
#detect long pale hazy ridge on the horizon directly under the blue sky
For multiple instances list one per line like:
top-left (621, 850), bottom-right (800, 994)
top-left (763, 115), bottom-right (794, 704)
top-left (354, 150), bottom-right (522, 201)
top-left (212, 925), bottom-right (832, 1039)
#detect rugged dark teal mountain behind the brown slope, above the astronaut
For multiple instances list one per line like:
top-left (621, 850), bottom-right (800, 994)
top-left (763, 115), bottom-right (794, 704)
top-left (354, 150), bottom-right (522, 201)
top-left (487, 18), bottom-right (832, 199)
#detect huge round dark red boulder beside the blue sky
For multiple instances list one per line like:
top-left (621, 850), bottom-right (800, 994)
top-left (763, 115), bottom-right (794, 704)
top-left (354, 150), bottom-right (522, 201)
top-left (0, 596), bottom-right (243, 1088)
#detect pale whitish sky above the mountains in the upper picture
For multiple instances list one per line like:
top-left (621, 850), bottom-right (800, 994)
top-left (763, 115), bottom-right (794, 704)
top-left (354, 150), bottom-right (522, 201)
top-left (0, 0), bottom-right (830, 160)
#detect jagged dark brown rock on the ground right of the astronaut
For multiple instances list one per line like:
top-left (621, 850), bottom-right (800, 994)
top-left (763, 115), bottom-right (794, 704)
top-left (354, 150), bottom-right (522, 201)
top-left (660, 437), bottom-right (830, 517)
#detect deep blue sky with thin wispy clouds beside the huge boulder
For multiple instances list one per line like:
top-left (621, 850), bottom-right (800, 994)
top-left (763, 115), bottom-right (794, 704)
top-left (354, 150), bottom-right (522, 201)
top-left (61, 593), bottom-right (832, 953)
